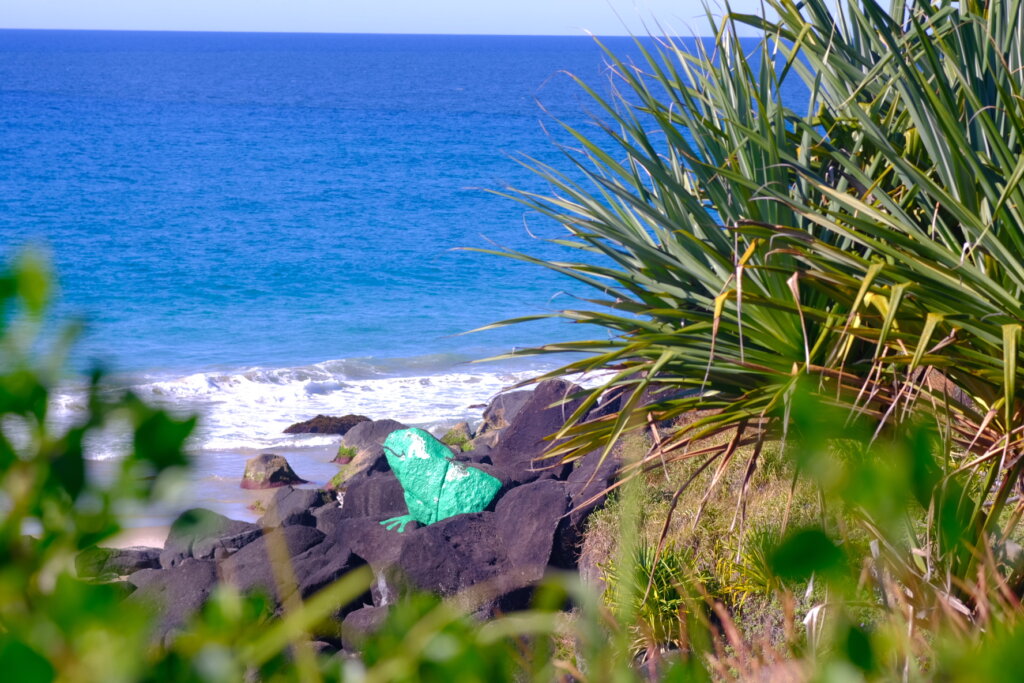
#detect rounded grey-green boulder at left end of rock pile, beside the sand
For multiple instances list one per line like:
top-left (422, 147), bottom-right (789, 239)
top-left (160, 508), bottom-right (262, 569)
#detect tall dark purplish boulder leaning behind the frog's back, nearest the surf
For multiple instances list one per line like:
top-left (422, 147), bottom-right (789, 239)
top-left (490, 380), bottom-right (583, 484)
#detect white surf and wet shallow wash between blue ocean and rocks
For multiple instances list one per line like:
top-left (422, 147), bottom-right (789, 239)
top-left (69, 352), bottom-right (565, 526)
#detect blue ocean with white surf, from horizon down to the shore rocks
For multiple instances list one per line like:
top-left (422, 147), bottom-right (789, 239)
top-left (0, 31), bottom-right (806, 524)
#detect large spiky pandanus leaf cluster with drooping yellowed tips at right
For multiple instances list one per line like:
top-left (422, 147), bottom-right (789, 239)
top-left (485, 0), bottom-right (1024, 589)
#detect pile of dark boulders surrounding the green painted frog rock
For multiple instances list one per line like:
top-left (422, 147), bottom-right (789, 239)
top-left (94, 381), bottom-right (620, 648)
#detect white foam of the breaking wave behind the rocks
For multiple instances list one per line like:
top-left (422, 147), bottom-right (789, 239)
top-left (54, 356), bottom-right (577, 460)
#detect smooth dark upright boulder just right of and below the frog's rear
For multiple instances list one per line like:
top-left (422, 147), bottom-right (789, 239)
top-left (495, 479), bottom-right (568, 581)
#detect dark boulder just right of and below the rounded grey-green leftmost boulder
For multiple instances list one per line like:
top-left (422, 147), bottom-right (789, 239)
top-left (220, 526), bottom-right (324, 602)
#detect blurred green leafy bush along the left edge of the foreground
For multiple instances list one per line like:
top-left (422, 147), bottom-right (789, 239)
top-left (0, 254), bottom-right (195, 680)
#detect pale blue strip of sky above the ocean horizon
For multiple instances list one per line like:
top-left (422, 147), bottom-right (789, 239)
top-left (0, 0), bottom-right (760, 35)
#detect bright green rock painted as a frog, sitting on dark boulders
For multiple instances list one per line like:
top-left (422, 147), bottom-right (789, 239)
top-left (381, 427), bottom-right (502, 533)
